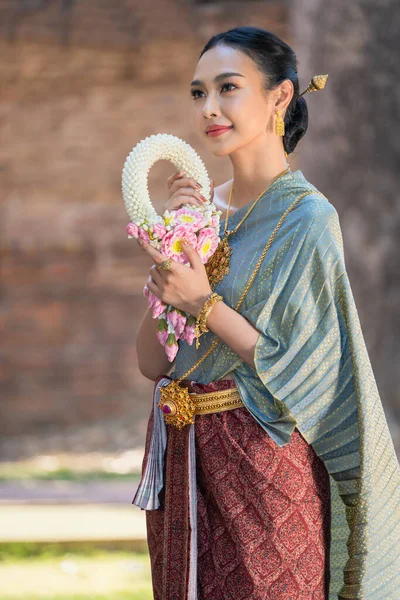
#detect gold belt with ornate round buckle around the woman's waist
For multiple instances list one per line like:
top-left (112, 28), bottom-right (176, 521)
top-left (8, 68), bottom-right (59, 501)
top-left (158, 386), bottom-right (244, 429)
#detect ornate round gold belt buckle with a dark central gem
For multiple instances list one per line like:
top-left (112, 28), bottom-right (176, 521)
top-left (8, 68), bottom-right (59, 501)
top-left (157, 381), bottom-right (196, 429)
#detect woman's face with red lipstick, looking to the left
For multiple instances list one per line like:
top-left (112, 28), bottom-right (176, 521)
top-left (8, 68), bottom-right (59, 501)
top-left (191, 44), bottom-right (284, 156)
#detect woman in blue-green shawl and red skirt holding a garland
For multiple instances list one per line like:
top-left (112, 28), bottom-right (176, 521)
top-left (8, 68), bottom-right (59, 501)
top-left (133, 27), bottom-right (400, 600)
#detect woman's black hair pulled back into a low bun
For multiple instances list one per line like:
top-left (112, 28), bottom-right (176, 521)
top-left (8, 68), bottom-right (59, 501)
top-left (199, 27), bottom-right (308, 154)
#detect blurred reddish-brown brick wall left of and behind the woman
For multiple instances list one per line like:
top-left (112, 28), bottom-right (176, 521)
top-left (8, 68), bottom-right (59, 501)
top-left (0, 0), bottom-right (287, 455)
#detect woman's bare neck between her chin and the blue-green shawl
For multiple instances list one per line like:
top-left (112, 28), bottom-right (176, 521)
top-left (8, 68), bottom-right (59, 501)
top-left (229, 135), bottom-right (288, 208)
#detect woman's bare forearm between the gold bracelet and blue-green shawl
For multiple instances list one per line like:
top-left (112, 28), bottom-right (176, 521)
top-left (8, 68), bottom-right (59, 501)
top-left (203, 301), bottom-right (260, 368)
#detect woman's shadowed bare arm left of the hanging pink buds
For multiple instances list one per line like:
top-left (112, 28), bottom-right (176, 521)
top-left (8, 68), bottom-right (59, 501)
top-left (136, 309), bottom-right (174, 381)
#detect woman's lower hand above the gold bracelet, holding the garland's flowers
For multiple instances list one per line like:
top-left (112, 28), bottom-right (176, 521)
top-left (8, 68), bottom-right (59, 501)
top-left (137, 238), bottom-right (212, 318)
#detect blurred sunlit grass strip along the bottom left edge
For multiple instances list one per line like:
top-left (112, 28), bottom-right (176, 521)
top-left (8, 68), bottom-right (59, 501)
top-left (0, 544), bottom-right (153, 600)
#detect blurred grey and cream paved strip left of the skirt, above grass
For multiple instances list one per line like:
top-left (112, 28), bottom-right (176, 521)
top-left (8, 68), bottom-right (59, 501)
top-left (0, 478), bottom-right (146, 548)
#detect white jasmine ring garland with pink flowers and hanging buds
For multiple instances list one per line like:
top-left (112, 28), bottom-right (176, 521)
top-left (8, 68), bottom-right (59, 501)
top-left (122, 133), bottom-right (221, 362)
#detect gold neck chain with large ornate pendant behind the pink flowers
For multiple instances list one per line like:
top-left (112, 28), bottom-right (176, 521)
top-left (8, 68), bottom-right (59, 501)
top-left (205, 167), bottom-right (290, 290)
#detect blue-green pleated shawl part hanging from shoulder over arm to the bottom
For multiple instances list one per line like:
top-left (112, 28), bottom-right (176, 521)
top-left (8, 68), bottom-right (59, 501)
top-left (253, 200), bottom-right (400, 600)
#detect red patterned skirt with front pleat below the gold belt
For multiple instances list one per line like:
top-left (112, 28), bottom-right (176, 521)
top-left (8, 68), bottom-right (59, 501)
top-left (143, 379), bottom-right (330, 600)
